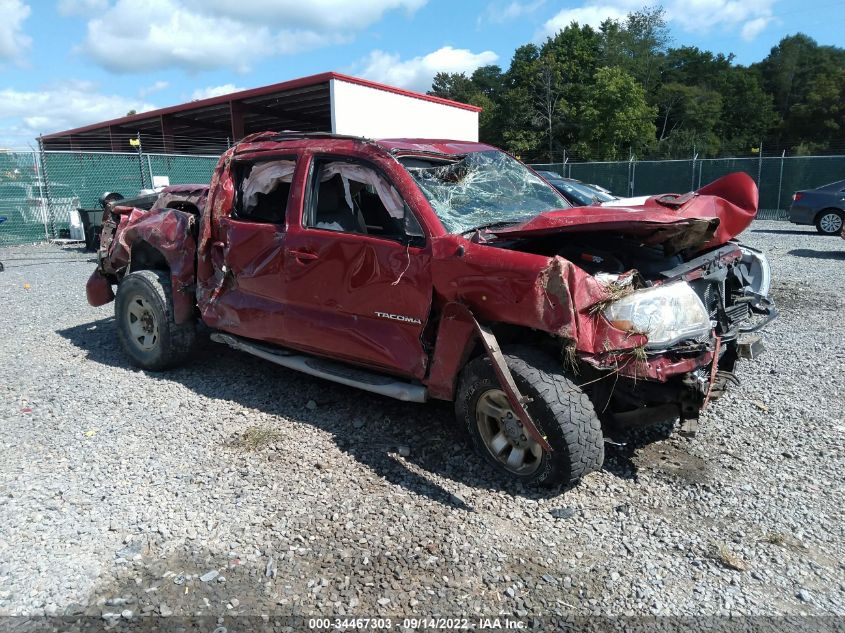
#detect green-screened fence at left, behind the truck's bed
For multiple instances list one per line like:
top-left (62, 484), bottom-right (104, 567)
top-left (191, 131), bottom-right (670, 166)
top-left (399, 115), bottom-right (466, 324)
top-left (0, 152), bottom-right (218, 246)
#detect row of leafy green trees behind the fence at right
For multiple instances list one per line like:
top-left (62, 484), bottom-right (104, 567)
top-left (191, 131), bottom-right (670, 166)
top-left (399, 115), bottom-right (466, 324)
top-left (429, 8), bottom-right (845, 162)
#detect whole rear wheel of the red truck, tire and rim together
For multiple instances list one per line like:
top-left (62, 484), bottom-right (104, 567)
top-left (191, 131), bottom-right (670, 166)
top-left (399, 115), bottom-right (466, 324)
top-left (114, 270), bottom-right (196, 370)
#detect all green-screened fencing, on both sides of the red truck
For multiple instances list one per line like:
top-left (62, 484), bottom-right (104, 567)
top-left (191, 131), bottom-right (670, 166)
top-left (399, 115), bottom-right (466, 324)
top-left (0, 151), bottom-right (845, 246)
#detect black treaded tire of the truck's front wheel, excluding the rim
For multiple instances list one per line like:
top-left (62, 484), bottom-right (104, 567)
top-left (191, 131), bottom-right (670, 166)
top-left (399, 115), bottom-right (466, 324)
top-left (455, 346), bottom-right (604, 487)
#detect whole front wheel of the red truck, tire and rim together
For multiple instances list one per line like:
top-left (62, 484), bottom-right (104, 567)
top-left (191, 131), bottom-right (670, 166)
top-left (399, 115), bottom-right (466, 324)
top-left (455, 347), bottom-right (604, 486)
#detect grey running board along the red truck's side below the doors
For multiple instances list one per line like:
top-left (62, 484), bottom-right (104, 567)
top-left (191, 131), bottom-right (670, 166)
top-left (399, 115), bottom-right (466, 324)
top-left (211, 332), bottom-right (428, 402)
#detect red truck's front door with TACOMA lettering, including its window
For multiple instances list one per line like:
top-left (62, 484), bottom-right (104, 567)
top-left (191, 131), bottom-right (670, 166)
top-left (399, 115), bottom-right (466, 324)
top-left (285, 156), bottom-right (432, 379)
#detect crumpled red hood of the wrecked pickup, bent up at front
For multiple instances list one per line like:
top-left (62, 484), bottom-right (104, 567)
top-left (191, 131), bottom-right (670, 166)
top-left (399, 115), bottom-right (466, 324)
top-left (490, 172), bottom-right (758, 253)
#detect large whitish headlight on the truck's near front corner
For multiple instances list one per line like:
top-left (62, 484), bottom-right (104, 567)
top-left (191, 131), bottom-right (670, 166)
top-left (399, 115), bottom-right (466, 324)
top-left (604, 281), bottom-right (712, 349)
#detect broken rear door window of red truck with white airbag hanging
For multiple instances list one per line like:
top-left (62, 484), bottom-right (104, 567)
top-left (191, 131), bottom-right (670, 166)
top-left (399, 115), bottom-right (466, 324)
top-left (235, 159), bottom-right (296, 224)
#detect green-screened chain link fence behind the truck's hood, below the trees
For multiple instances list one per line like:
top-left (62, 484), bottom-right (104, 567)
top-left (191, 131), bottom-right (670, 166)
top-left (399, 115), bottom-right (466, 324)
top-left (532, 156), bottom-right (845, 220)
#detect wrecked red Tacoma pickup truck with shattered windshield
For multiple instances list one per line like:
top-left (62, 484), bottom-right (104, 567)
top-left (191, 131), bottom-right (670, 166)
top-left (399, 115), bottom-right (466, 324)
top-left (87, 132), bottom-right (776, 484)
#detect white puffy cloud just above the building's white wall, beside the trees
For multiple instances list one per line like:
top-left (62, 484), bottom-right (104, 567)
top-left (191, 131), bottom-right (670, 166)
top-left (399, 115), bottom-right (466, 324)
top-left (361, 46), bottom-right (499, 91)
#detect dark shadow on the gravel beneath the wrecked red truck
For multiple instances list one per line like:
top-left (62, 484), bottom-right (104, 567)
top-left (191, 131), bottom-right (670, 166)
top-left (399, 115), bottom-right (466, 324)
top-left (57, 318), bottom-right (562, 512)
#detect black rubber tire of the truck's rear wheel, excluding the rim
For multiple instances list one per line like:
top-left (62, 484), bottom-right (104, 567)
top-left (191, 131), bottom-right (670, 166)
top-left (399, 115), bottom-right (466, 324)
top-left (114, 270), bottom-right (196, 371)
